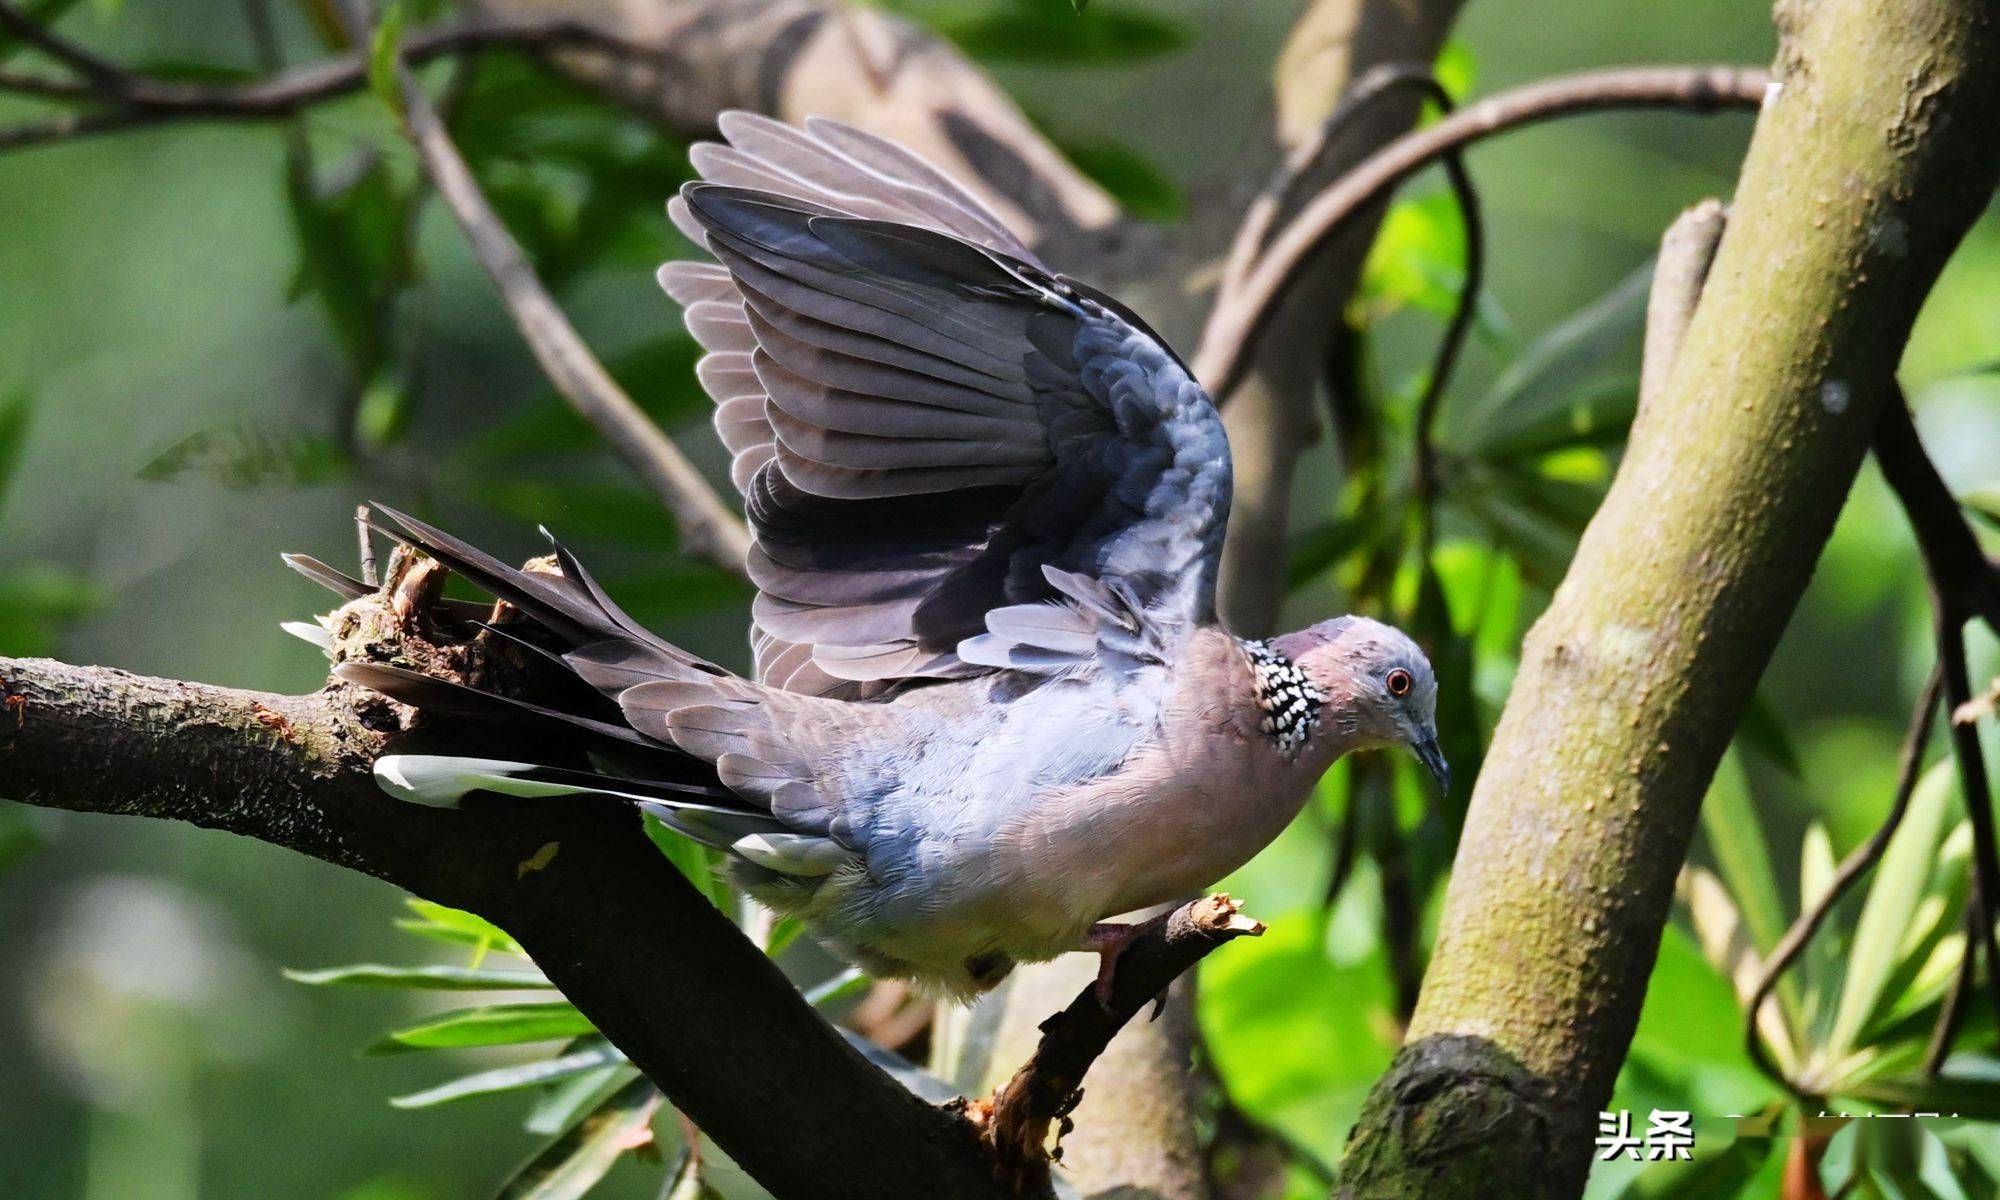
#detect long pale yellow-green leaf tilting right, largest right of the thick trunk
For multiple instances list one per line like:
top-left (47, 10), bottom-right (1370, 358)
top-left (1826, 762), bottom-right (1952, 1060)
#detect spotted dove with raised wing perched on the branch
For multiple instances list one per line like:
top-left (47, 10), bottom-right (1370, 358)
top-left (290, 112), bottom-right (1450, 998)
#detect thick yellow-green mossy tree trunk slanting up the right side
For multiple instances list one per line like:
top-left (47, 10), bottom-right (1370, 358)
top-left (1338, 0), bottom-right (2000, 1200)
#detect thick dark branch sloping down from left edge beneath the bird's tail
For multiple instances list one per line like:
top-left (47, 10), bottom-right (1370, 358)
top-left (0, 648), bottom-right (1002, 1200)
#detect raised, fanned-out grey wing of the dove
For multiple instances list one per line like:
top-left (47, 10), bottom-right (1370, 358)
top-left (660, 114), bottom-right (1230, 696)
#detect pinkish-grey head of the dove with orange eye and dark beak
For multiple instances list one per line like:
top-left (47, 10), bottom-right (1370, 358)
top-left (1260, 616), bottom-right (1452, 790)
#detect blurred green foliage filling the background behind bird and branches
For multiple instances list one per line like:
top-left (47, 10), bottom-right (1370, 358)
top-left (0, 0), bottom-right (2000, 1200)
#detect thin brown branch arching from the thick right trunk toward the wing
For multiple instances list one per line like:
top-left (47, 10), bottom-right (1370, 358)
top-left (1194, 66), bottom-right (1768, 396)
